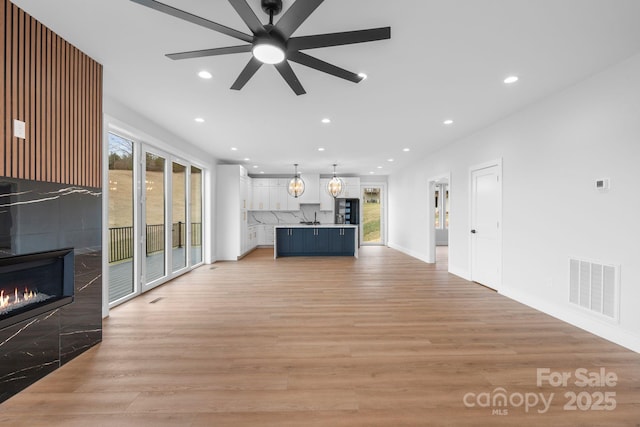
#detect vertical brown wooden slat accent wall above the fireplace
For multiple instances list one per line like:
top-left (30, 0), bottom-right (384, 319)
top-left (0, 0), bottom-right (102, 187)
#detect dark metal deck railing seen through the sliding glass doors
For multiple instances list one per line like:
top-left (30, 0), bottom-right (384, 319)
top-left (109, 221), bottom-right (202, 263)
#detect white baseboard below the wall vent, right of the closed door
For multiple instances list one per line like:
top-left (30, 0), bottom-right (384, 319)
top-left (500, 288), bottom-right (640, 353)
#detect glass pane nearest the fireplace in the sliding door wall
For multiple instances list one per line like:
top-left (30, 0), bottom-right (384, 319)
top-left (107, 133), bottom-right (135, 303)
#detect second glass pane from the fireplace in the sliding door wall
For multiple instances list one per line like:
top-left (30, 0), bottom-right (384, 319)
top-left (144, 153), bottom-right (166, 284)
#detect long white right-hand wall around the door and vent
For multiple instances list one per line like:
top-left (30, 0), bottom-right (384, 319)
top-left (389, 55), bottom-right (640, 351)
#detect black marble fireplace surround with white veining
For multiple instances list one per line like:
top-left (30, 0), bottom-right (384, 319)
top-left (0, 177), bottom-right (102, 402)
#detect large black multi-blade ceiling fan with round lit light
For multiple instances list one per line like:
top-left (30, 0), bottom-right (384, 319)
top-left (131, 0), bottom-right (391, 95)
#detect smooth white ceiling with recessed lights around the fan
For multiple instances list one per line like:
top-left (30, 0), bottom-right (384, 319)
top-left (13, 0), bottom-right (640, 176)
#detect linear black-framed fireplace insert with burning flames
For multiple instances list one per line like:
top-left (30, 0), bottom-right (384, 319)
top-left (0, 249), bottom-right (74, 329)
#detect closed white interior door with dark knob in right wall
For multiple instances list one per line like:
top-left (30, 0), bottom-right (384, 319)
top-left (470, 165), bottom-right (502, 289)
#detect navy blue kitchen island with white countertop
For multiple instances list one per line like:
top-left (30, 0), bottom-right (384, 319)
top-left (273, 224), bottom-right (358, 258)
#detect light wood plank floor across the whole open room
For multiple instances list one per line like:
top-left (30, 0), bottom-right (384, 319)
top-left (0, 247), bottom-right (640, 427)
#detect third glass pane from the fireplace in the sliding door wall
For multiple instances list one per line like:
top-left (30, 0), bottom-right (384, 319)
top-left (171, 162), bottom-right (187, 271)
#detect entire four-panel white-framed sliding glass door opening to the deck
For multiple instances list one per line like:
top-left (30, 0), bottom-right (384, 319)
top-left (105, 133), bottom-right (203, 306)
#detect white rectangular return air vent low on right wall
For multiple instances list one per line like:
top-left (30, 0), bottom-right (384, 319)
top-left (569, 258), bottom-right (620, 321)
